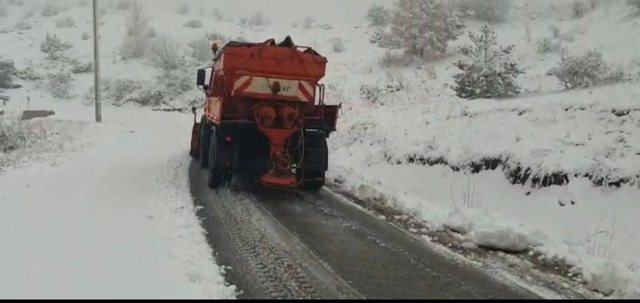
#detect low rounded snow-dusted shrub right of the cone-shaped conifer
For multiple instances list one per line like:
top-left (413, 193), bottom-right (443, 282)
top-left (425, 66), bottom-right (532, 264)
top-left (548, 50), bottom-right (610, 89)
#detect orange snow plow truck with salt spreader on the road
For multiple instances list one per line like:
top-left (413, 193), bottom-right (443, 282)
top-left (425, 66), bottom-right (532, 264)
top-left (190, 37), bottom-right (340, 191)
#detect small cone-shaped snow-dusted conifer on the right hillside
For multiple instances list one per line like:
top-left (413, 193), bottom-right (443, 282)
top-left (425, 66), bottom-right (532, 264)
top-left (453, 25), bottom-right (524, 99)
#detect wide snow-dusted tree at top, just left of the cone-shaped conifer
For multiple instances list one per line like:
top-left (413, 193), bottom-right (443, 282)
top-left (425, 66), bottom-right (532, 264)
top-left (380, 0), bottom-right (464, 58)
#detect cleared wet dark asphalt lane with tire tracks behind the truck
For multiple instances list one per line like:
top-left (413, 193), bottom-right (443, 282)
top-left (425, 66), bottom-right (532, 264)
top-left (189, 162), bottom-right (538, 299)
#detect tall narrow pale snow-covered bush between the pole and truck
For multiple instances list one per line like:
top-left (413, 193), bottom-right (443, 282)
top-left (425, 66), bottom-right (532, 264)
top-left (120, 2), bottom-right (151, 59)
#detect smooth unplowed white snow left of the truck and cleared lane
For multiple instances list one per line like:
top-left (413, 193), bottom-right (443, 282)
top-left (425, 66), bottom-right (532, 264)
top-left (0, 108), bottom-right (235, 298)
